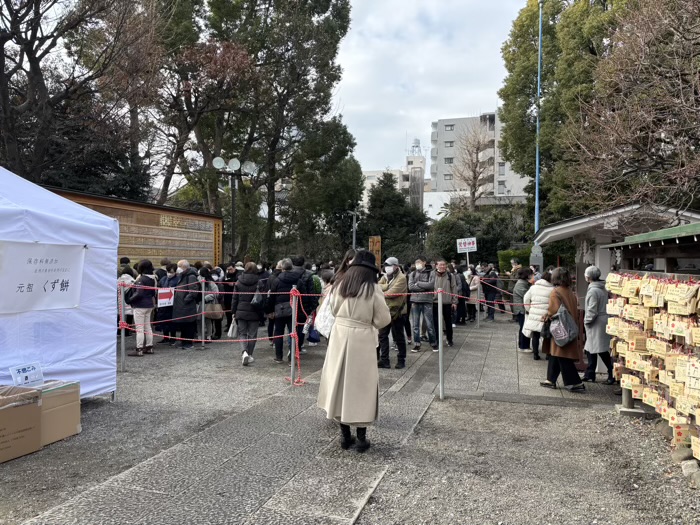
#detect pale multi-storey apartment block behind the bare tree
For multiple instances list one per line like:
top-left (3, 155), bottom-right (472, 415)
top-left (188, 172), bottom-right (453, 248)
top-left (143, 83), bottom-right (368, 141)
top-left (430, 113), bottom-right (528, 205)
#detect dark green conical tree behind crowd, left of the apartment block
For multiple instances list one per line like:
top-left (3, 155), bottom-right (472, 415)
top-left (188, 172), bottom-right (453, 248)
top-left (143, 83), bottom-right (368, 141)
top-left (358, 173), bottom-right (428, 263)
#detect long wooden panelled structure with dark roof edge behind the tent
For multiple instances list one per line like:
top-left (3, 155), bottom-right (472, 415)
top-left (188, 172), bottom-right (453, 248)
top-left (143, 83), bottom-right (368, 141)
top-left (47, 188), bottom-right (223, 267)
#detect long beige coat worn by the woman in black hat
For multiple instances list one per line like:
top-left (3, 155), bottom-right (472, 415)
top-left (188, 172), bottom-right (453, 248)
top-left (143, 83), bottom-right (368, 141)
top-left (318, 285), bottom-right (391, 427)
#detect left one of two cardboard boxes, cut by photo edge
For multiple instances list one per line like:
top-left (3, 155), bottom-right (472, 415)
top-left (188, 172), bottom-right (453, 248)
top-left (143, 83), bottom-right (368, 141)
top-left (0, 386), bottom-right (41, 463)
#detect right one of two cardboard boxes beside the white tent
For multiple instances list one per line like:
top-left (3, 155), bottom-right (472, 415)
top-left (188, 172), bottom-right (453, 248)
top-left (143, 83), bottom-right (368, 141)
top-left (36, 381), bottom-right (82, 447)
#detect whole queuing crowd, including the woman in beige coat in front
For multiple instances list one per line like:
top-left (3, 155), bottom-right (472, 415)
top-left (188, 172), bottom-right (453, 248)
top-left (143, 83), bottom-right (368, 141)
top-left (118, 250), bottom-right (615, 452)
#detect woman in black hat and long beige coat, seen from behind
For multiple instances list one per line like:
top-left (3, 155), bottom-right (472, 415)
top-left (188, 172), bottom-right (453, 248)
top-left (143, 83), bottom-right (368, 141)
top-left (318, 251), bottom-right (391, 452)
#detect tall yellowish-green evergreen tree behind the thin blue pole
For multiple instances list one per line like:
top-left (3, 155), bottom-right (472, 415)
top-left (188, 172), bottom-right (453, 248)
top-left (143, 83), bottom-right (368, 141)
top-left (499, 0), bottom-right (627, 226)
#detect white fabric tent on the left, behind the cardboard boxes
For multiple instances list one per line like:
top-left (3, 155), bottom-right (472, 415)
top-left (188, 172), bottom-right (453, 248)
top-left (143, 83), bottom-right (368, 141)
top-left (0, 167), bottom-right (119, 397)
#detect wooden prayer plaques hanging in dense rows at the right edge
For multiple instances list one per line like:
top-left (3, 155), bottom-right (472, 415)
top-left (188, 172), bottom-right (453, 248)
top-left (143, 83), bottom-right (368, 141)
top-left (606, 274), bottom-right (700, 459)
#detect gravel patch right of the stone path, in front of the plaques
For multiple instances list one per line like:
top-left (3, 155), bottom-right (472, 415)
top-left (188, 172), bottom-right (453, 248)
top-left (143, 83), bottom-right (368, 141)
top-left (357, 400), bottom-right (700, 525)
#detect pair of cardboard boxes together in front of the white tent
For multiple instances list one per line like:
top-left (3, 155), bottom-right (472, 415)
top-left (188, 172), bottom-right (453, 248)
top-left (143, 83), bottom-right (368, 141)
top-left (0, 381), bottom-right (81, 463)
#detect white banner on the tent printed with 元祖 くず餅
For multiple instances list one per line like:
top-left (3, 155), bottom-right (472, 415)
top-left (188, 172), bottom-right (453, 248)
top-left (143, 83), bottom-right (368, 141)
top-left (0, 241), bottom-right (87, 314)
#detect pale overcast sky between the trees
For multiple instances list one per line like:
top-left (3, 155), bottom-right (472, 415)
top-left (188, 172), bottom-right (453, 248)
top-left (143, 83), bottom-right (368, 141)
top-left (335, 0), bottom-right (526, 172)
